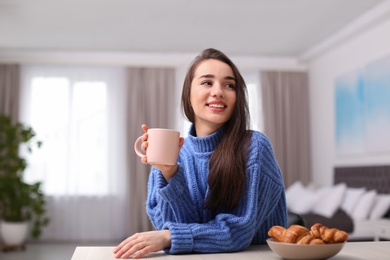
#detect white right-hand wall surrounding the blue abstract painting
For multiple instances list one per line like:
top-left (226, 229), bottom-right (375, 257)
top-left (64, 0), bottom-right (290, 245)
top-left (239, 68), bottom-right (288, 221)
top-left (308, 16), bottom-right (390, 185)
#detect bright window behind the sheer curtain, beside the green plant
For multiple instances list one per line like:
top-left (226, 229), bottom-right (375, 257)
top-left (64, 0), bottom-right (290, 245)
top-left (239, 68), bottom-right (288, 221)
top-left (19, 68), bottom-right (125, 195)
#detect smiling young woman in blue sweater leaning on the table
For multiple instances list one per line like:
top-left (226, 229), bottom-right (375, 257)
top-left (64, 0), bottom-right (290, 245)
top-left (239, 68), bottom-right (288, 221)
top-left (114, 49), bottom-right (287, 258)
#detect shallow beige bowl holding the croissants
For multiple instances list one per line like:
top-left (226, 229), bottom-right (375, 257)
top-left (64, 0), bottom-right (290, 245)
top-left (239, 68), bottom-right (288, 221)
top-left (267, 238), bottom-right (346, 260)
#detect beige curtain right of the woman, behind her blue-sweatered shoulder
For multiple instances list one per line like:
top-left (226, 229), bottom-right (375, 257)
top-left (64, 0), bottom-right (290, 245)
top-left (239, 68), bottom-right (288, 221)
top-left (260, 71), bottom-right (310, 187)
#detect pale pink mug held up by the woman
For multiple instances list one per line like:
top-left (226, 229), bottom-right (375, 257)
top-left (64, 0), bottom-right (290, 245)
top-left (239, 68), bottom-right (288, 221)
top-left (134, 128), bottom-right (180, 165)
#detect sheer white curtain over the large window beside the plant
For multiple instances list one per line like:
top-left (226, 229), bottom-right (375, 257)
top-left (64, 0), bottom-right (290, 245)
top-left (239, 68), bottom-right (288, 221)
top-left (21, 66), bottom-right (129, 241)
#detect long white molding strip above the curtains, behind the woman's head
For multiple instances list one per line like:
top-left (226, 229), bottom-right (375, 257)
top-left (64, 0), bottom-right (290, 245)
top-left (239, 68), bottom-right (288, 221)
top-left (0, 50), bottom-right (306, 70)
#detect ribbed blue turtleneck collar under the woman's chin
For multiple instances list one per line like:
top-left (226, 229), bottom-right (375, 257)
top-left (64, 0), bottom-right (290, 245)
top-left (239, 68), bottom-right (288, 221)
top-left (186, 124), bottom-right (224, 153)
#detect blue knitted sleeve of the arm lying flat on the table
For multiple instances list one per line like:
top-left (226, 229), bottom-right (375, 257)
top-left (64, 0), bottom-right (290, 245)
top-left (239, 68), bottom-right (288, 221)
top-left (162, 133), bottom-right (287, 254)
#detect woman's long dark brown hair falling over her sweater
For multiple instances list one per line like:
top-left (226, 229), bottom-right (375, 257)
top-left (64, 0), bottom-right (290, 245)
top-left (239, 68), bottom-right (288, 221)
top-left (181, 49), bottom-right (250, 210)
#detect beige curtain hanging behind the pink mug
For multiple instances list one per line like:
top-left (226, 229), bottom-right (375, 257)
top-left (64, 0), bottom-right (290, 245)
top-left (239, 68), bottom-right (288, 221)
top-left (126, 68), bottom-right (176, 235)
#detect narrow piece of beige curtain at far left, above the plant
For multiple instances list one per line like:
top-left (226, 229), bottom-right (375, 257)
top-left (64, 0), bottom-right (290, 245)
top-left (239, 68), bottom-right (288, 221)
top-left (0, 64), bottom-right (20, 123)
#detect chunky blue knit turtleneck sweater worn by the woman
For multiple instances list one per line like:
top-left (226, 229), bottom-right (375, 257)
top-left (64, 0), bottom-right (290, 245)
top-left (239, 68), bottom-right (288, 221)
top-left (146, 126), bottom-right (287, 254)
